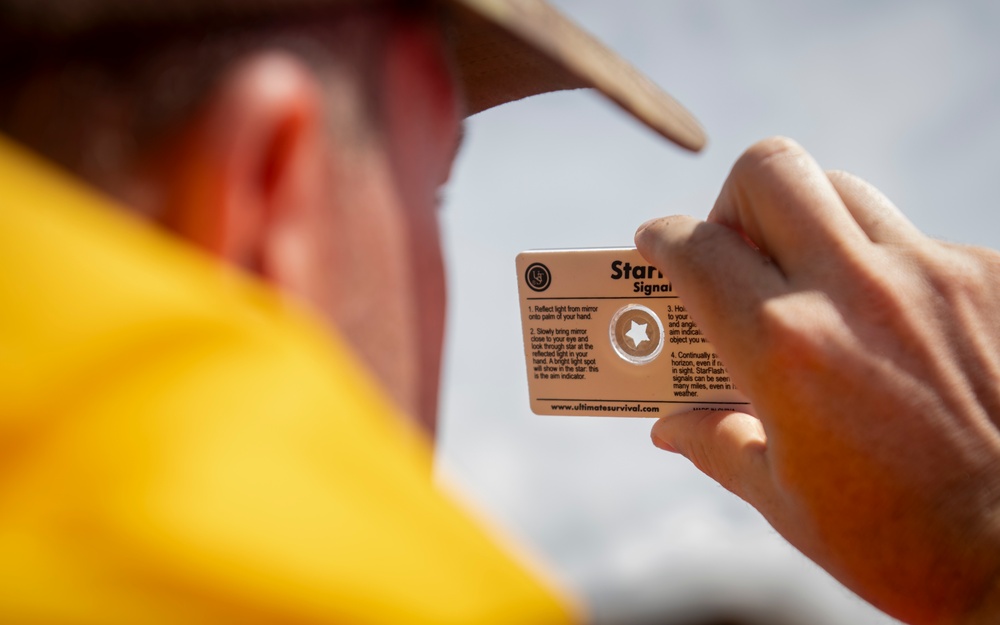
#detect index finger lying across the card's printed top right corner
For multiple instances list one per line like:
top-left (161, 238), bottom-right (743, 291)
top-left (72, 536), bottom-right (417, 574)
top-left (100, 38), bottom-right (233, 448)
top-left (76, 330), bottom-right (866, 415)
top-left (635, 217), bottom-right (789, 376)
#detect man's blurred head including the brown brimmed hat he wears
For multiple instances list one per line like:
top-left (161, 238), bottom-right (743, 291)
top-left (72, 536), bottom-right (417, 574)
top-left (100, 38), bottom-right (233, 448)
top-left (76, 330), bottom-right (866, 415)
top-left (0, 0), bottom-right (705, 430)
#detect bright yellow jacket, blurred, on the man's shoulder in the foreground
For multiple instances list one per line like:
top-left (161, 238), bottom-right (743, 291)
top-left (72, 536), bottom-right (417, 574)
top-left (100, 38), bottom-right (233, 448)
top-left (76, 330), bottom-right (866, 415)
top-left (0, 137), bottom-right (570, 625)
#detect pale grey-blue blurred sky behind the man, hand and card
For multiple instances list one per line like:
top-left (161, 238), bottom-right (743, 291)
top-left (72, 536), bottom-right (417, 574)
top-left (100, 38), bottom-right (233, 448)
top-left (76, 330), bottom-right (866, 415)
top-left (438, 0), bottom-right (1000, 625)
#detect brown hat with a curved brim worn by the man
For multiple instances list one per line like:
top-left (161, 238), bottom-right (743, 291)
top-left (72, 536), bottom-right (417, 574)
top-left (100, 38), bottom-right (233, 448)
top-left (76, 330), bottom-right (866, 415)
top-left (0, 0), bottom-right (705, 151)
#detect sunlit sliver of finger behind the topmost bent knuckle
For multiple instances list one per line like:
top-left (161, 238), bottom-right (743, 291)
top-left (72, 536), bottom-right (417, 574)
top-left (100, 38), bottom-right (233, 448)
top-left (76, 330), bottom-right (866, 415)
top-left (826, 171), bottom-right (920, 243)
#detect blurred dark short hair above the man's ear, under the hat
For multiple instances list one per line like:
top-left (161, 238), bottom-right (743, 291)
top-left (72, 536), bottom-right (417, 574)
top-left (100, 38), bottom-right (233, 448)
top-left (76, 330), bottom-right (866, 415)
top-left (0, 0), bottom-right (427, 184)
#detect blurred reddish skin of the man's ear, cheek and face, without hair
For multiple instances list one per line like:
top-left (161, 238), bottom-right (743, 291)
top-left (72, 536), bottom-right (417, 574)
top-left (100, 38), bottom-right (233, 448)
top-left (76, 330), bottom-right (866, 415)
top-left (132, 18), bottom-right (462, 433)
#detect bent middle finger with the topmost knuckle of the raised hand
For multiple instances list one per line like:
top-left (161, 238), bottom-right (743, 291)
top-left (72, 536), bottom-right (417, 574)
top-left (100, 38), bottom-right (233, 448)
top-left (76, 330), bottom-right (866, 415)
top-left (708, 138), bottom-right (868, 277)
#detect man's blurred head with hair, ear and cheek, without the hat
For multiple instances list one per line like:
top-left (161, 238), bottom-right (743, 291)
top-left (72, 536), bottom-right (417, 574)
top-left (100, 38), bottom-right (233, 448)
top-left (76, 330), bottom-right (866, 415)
top-left (0, 0), bottom-right (463, 429)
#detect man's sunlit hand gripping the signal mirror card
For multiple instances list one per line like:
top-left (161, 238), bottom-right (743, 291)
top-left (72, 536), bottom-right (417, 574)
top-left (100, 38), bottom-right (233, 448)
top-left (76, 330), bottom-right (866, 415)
top-left (636, 139), bottom-right (1000, 624)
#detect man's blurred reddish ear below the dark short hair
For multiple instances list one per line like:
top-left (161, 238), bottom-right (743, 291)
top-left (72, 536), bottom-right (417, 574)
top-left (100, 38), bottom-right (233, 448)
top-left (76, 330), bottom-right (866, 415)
top-left (156, 51), bottom-right (327, 291)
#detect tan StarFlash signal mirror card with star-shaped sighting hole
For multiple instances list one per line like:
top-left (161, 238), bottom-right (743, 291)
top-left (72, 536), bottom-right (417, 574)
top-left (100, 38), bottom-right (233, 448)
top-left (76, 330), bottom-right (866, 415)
top-left (517, 248), bottom-right (751, 417)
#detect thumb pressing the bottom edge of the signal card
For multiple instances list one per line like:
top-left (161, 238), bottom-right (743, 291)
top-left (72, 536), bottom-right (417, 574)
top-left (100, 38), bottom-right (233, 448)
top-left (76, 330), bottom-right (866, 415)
top-left (652, 411), bottom-right (774, 507)
